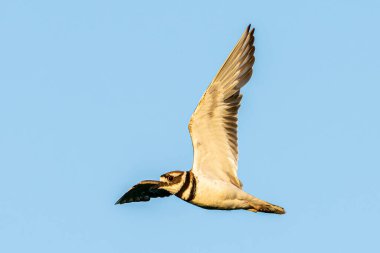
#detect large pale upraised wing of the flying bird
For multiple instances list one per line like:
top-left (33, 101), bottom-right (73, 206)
top-left (189, 25), bottom-right (255, 188)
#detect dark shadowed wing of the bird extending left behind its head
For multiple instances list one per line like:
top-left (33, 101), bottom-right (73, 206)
top-left (115, 180), bottom-right (172, 205)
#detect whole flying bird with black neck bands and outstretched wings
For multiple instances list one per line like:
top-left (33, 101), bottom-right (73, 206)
top-left (115, 25), bottom-right (285, 214)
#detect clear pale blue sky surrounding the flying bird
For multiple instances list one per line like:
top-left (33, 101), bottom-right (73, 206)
top-left (0, 0), bottom-right (380, 253)
